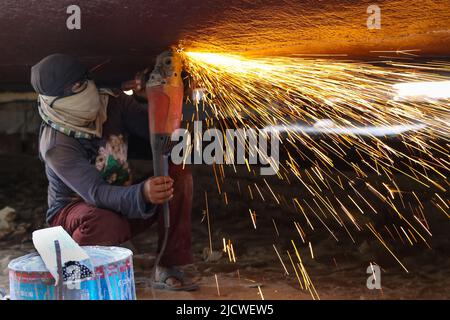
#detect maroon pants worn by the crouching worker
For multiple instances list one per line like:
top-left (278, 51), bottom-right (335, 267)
top-left (51, 165), bottom-right (193, 267)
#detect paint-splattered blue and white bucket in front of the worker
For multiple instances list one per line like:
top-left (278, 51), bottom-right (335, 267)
top-left (8, 246), bottom-right (136, 300)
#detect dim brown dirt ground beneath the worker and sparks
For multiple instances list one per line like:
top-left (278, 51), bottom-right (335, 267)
top-left (0, 155), bottom-right (450, 300)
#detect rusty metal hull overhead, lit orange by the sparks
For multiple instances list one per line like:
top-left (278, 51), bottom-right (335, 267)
top-left (0, 0), bottom-right (450, 89)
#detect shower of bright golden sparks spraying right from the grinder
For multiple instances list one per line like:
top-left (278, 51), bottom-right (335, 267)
top-left (180, 50), bottom-right (450, 299)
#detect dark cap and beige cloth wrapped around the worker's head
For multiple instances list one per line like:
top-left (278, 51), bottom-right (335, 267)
top-left (31, 54), bottom-right (108, 139)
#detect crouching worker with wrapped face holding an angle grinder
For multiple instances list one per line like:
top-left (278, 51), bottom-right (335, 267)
top-left (31, 54), bottom-right (197, 290)
